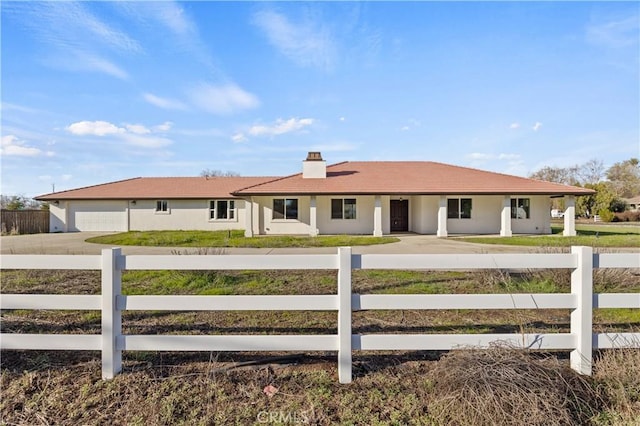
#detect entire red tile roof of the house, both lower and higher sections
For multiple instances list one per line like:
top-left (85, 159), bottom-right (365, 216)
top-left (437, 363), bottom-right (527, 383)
top-left (36, 161), bottom-right (595, 201)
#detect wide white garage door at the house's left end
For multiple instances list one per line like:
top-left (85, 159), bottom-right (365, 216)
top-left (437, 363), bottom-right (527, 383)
top-left (69, 201), bottom-right (127, 231)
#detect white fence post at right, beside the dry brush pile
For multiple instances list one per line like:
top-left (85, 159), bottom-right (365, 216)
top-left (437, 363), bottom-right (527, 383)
top-left (570, 247), bottom-right (593, 376)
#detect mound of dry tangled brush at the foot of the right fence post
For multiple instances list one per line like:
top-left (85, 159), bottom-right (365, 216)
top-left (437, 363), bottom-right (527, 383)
top-left (429, 347), bottom-right (604, 426)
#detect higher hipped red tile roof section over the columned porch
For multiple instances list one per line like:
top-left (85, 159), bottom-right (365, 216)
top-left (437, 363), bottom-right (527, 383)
top-left (234, 161), bottom-right (594, 195)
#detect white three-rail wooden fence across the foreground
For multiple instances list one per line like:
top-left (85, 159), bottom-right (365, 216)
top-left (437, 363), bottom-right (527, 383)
top-left (0, 247), bottom-right (640, 383)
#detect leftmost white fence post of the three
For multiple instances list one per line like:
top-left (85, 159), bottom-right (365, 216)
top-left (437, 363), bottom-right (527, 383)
top-left (102, 248), bottom-right (122, 379)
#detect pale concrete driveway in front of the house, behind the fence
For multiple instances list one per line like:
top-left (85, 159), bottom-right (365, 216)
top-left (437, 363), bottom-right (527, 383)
top-left (0, 232), bottom-right (538, 254)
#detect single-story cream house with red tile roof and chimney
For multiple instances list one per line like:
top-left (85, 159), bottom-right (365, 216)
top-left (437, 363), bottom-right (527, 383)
top-left (36, 152), bottom-right (594, 237)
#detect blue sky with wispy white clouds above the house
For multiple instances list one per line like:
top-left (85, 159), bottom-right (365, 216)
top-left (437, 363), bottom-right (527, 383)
top-left (0, 1), bottom-right (640, 196)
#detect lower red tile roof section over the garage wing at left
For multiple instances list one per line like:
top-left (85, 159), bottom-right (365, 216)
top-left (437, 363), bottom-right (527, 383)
top-left (36, 176), bottom-right (277, 201)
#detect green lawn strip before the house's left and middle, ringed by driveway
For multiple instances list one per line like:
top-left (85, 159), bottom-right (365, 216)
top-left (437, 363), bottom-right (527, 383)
top-left (87, 230), bottom-right (399, 248)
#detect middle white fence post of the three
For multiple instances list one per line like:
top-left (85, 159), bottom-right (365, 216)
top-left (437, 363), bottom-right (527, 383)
top-left (338, 247), bottom-right (352, 383)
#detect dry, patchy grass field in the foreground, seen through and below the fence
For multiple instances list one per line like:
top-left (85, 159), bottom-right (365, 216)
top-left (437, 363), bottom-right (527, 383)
top-left (0, 262), bottom-right (640, 426)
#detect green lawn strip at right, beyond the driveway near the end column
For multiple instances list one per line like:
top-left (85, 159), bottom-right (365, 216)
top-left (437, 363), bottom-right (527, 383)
top-left (460, 224), bottom-right (640, 247)
